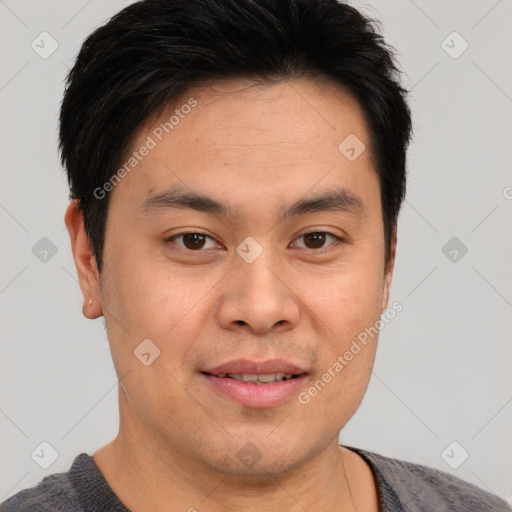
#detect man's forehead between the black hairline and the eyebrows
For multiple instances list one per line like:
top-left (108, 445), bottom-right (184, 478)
top-left (116, 79), bottom-right (377, 212)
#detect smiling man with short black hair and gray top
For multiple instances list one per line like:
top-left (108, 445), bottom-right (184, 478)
top-left (1, 0), bottom-right (509, 512)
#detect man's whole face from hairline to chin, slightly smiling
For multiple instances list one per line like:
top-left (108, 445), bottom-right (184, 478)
top-left (68, 80), bottom-right (394, 476)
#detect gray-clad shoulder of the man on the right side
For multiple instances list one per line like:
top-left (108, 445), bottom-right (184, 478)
top-left (346, 447), bottom-right (512, 512)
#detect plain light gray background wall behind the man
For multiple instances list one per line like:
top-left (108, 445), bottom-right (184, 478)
top-left (0, 0), bottom-right (512, 501)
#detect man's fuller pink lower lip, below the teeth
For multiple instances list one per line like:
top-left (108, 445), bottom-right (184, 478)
top-left (203, 374), bottom-right (307, 408)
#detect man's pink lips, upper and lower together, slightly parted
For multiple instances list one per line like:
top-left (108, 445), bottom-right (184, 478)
top-left (202, 359), bottom-right (308, 408)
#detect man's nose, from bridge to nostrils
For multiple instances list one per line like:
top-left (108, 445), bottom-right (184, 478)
top-left (217, 251), bottom-right (301, 335)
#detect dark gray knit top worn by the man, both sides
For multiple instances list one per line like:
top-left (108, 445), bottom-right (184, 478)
top-left (0, 446), bottom-right (512, 512)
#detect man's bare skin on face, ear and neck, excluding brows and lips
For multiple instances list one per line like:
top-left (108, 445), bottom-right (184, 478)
top-left (66, 79), bottom-right (396, 512)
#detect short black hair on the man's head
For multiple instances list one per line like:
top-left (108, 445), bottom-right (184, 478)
top-left (59, 0), bottom-right (412, 272)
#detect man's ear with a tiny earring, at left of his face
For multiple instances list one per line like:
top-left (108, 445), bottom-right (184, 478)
top-left (64, 200), bottom-right (103, 319)
